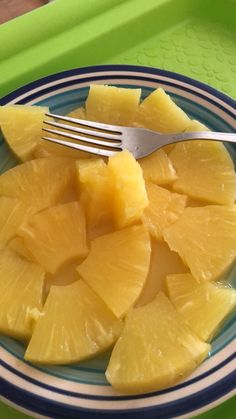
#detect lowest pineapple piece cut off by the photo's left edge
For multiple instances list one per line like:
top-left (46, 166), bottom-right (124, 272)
top-left (0, 248), bottom-right (45, 339)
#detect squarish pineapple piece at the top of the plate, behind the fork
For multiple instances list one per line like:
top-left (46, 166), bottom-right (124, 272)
top-left (85, 84), bottom-right (141, 126)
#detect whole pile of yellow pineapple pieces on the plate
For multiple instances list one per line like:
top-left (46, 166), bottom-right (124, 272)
top-left (0, 85), bottom-right (236, 393)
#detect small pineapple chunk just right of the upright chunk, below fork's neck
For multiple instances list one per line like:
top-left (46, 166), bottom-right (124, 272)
top-left (139, 150), bottom-right (177, 185)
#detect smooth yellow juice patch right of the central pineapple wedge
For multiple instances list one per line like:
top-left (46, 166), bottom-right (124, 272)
top-left (135, 239), bottom-right (189, 307)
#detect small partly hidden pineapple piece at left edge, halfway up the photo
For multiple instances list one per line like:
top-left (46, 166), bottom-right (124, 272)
top-left (0, 196), bottom-right (28, 249)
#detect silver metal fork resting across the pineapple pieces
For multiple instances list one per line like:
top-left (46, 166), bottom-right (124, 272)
top-left (42, 113), bottom-right (236, 159)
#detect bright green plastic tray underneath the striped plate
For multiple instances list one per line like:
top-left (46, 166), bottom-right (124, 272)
top-left (0, 0), bottom-right (236, 419)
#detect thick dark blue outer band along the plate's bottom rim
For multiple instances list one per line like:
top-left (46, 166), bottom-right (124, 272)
top-left (0, 372), bottom-right (236, 419)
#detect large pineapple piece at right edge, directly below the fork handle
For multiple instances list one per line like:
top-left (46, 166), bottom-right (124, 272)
top-left (169, 140), bottom-right (236, 205)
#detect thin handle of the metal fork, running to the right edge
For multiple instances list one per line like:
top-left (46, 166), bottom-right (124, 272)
top-left (168, 131), bottom-right (236, 144)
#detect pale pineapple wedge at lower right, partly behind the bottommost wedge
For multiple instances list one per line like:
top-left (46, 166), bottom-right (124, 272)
top-left (166, 274), bottom-right (236, 341)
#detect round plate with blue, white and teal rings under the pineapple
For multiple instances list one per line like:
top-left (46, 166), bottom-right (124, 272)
top-left (0, 65), bottom-right (236, 419)
